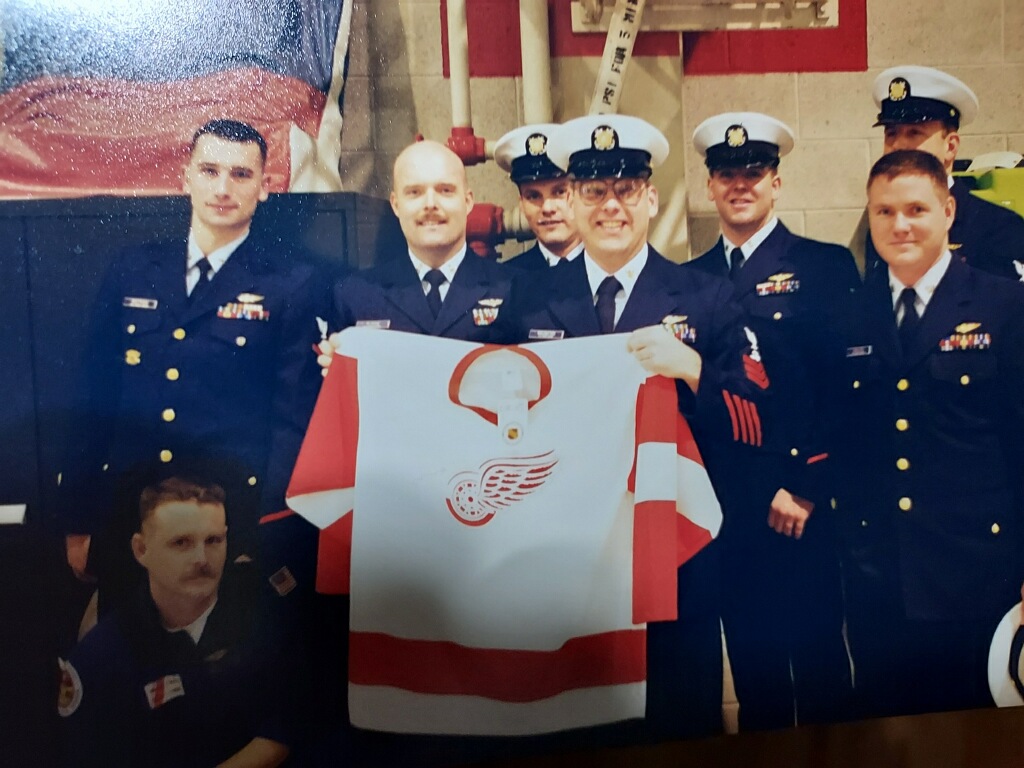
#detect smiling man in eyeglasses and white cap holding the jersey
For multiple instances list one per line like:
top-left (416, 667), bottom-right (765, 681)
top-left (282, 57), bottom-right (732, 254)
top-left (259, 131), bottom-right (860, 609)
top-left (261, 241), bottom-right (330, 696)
top-left (519, 115), bottom-right (767, 739)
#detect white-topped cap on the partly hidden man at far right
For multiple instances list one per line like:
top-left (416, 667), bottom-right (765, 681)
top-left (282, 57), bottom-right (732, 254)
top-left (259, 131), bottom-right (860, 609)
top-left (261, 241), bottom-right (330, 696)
top-left (871, 65), bottom-right (978, 128)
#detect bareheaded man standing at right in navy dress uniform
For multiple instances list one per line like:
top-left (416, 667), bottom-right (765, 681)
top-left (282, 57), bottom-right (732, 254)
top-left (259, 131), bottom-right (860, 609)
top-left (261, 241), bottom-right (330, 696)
top-left (834, 151), bottom-right (1024, 716)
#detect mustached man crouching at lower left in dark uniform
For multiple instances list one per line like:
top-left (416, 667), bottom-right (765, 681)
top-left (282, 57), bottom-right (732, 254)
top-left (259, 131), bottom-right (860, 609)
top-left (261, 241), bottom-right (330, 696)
top-left (58, 476), bottom-right (289, 768)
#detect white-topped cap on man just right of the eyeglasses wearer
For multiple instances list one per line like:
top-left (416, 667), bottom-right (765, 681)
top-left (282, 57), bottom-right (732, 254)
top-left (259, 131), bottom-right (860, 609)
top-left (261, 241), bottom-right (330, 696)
top-left (693, 112), bottom-right (795, 171)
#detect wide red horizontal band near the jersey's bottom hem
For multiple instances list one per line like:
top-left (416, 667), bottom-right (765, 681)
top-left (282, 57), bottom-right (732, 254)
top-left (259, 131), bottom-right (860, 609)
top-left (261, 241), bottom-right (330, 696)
top-left (348, 630), bottom-right (647, 701)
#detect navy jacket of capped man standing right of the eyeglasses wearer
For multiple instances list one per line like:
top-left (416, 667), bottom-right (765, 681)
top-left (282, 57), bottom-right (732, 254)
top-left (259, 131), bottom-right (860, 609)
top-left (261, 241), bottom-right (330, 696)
top-left (687, 222), bottom-right (860, 529)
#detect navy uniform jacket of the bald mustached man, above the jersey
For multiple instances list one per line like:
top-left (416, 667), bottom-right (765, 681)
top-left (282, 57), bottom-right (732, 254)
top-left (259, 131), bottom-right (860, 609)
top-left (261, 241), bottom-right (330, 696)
top-left (332, 251), bottom-right (515, 344)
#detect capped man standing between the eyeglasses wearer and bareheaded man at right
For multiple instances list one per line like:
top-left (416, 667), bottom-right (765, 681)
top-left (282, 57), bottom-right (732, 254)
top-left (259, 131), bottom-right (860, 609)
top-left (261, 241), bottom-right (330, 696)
top-left (690, 113), bottom-right (860, 730)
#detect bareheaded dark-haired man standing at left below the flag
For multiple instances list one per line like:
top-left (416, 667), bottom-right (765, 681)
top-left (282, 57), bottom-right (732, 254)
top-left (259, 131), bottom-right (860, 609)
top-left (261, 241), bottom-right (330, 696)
top-left (62, 120), bottom-right (328, 595)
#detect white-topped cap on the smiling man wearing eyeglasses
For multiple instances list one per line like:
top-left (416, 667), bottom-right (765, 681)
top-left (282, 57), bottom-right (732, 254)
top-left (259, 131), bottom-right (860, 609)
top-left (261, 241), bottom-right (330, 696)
top-left (548, 115), bottom-right (669, 178)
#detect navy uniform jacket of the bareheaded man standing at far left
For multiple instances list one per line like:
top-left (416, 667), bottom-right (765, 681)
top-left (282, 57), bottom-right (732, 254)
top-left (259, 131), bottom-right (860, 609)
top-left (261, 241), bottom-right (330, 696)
top-left (63, 233), bottom-right (329, 534)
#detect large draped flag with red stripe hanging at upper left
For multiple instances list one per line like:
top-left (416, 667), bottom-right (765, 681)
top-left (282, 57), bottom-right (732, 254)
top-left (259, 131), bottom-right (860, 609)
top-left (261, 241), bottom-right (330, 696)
top-left (0, 0), bottom-right (352, 198)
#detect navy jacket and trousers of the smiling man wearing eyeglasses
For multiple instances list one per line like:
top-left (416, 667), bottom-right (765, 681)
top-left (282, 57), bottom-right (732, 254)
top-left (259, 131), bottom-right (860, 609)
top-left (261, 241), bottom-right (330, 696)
top-left (519, 248), bottom-right (765, 739)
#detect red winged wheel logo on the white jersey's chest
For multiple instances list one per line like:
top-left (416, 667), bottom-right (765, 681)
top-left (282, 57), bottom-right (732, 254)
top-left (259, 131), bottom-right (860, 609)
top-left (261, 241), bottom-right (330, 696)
top-left (447, 451), bottom-right (558, 525)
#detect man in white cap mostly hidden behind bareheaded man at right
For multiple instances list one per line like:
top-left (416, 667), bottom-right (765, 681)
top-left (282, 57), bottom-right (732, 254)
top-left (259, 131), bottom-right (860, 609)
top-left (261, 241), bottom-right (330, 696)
top-left (858, 66), bottom-right (1024, 280)
